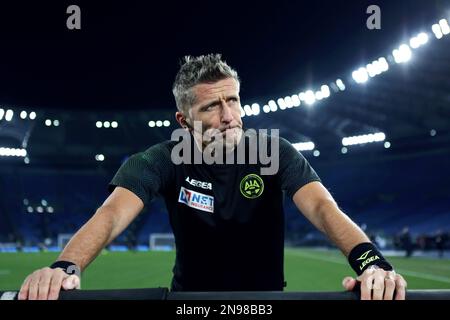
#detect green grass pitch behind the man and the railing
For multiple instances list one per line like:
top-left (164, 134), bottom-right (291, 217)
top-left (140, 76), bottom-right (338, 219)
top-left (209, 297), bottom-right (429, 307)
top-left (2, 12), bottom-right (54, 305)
top-left (0, 249), bottom-right (450, 291)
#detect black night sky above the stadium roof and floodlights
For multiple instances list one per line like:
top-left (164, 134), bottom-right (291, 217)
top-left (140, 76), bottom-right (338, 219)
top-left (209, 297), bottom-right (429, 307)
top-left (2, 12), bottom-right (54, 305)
top-left (0, 0), bottom-right (444, 110)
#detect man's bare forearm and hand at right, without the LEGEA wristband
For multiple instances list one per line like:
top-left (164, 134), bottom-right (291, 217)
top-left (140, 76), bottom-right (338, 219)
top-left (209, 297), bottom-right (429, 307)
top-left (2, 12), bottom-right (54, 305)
top-left (293, 181), bottom-right (407, 300)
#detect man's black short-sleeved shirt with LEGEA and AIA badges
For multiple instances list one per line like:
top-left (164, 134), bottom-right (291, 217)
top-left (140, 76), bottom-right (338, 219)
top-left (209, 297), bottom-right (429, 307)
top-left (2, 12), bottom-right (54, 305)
top-left (109, 131), bottom-right (320, 291)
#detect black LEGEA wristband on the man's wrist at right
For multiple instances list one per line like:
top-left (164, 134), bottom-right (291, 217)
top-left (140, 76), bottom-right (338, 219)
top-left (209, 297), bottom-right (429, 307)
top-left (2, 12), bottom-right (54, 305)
top-left (348, 242), bottom-right (393, 276)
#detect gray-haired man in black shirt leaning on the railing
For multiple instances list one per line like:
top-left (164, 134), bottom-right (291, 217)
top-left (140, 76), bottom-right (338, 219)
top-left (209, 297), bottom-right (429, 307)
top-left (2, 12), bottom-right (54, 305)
top-left (19, 55), bottom-right (406, 300)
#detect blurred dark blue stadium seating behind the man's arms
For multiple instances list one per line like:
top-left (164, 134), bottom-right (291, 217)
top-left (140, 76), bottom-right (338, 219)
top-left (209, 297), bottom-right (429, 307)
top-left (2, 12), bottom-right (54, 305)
top-left (0, 151), bottom-right (450, 251)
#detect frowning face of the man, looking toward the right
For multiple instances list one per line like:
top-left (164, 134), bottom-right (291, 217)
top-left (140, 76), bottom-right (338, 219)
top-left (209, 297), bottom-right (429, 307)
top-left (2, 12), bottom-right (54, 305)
top-left (181, 78), bottom-right (242, 148)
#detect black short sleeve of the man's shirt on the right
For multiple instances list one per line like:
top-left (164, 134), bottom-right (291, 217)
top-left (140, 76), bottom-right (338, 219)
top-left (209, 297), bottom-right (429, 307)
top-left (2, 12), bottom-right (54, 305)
top-left (278, 137), bottom-right (321, 198)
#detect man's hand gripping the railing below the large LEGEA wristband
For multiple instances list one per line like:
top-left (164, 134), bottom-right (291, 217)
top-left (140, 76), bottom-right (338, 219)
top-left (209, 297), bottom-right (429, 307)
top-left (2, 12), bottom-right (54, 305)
top-left (342, 266), bottom-right (407, 300)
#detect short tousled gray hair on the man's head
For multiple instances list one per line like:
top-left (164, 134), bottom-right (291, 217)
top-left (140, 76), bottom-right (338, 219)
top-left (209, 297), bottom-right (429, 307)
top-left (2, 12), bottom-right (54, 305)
top-left (172, 54), bottom-right (240, 112)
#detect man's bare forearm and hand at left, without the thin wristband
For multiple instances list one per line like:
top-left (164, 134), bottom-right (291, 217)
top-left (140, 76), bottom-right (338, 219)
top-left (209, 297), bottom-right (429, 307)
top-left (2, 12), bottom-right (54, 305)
top-left (19, 187), bottom-right (144, 300)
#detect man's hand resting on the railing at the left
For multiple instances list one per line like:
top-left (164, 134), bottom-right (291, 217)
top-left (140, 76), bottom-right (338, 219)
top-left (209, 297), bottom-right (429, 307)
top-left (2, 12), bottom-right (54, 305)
top-left (19, 267), bottom-right (80, 300)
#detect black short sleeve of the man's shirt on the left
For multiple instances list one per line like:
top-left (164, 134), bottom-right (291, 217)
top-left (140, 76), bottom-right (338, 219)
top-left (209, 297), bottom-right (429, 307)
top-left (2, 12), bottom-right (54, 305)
top-left (108, 144), bottom-right (173, 205)
